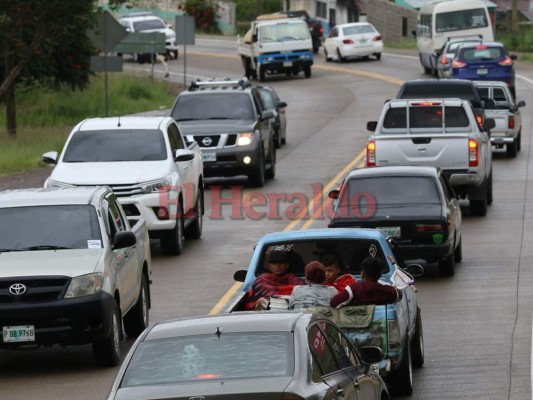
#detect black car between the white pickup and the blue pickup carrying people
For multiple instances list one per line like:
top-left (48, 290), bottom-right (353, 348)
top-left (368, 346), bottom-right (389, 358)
top-left (329, 166), bottom-right (462, 276)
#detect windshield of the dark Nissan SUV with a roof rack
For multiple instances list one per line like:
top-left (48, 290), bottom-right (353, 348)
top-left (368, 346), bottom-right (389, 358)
top-left (172, 92), bottom-right (255, 121)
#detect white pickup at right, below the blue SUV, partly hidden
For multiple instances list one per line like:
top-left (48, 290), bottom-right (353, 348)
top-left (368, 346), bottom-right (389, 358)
top-left (473, 81), bottom-right (526, 157)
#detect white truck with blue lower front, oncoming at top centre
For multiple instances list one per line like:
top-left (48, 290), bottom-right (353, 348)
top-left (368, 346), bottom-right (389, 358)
top-left (237, 14), bottom-right (313, 82)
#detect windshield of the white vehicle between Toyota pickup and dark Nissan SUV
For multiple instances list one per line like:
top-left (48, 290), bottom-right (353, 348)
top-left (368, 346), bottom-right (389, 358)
top-left (63, 129), bottom-right (167, 162)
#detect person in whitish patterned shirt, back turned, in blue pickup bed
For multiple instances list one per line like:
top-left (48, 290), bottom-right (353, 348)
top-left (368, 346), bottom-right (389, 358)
top-left (289, 261), bottom-right (337, 310)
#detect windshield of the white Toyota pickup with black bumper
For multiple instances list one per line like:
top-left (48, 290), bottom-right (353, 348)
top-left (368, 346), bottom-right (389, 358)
top-left (0, 205), bottom-right (102, 251)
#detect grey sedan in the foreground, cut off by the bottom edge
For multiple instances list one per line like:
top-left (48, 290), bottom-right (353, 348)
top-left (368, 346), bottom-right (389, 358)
top-left (108, 311), bottom-right (389, 400)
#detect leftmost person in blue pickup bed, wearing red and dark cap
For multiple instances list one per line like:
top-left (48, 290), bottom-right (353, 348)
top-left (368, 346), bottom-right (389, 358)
top-left (245, 249), bottom-right (305, 310)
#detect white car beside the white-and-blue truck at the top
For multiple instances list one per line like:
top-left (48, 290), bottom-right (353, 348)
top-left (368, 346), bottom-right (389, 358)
top-left (324, 22), bottom-right (383, 62)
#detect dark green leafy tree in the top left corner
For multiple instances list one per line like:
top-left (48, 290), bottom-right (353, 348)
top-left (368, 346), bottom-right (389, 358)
top-left (0, 0), bottom-right (134, 136)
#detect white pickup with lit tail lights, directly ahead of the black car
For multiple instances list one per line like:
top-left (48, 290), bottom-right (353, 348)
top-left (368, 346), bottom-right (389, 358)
top-left (366, 99), bottom-right (494, 215)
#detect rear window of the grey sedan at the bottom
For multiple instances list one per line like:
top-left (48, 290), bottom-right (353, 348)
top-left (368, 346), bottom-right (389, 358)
top-left (121, 332), bottom-right (294, 387)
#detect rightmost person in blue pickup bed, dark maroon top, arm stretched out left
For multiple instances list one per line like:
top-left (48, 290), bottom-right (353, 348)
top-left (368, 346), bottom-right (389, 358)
top-left (329, 257), bottom-right (402, 308)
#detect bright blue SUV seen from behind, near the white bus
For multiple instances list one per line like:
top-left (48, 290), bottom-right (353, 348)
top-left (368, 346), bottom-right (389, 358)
top-left (452, 42), bottom-right (516, 96)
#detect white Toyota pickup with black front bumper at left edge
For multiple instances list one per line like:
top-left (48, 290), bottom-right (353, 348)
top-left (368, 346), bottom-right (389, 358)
top-left (0, 187), bottom-right (151, 366)
